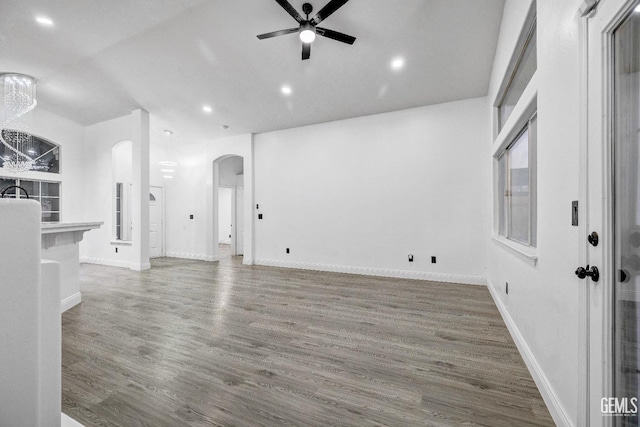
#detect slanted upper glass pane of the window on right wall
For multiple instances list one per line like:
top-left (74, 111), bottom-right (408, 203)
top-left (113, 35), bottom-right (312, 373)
top-left (498, 26), bottom-right (538, 129)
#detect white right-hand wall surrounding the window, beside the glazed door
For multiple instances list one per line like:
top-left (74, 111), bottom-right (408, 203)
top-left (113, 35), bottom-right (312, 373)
top-left (487, 0), bottom-right (581, 425)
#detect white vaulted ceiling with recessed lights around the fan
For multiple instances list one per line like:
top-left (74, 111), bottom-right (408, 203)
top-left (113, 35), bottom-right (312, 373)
top-left (0, 0), bottom-right (504, 139)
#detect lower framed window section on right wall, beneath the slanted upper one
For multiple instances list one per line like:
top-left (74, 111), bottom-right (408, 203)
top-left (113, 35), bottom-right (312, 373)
top-left (498, 115), bottom-right (537, 246)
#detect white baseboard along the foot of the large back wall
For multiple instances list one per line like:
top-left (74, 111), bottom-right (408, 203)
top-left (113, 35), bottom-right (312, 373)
top-left (253, 259), bottom-right (486, 286)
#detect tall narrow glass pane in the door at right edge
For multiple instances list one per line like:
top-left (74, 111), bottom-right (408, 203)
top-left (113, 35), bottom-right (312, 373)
top-left (614, 13), bottom-right (640, 418)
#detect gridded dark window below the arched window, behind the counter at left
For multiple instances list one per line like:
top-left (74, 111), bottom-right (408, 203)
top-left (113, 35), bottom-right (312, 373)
top-left (0, 177), bottom-right (60, 222)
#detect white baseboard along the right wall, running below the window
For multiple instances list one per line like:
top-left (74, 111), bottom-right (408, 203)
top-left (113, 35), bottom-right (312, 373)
top-left (487, 283), bottom-right (574, 427)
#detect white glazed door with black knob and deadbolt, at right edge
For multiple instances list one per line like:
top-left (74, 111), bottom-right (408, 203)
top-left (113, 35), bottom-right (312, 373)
top-left (576, 0), bottom-right (640, 426)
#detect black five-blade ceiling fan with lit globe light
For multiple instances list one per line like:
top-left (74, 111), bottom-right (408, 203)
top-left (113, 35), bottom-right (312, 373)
top-left (257, 0), bottom-right (356, 60)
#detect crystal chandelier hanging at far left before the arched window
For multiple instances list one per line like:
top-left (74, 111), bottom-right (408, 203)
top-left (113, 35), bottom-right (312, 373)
top-left (0, 73), bottom-right (38, 172)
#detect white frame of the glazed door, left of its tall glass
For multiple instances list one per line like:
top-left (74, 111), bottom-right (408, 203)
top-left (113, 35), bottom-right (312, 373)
top-left (578, 0), bottom-right (637, 427)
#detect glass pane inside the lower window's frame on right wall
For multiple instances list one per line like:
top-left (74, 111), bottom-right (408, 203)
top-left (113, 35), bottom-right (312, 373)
top-left (507, 131), bottom-right (531, 244)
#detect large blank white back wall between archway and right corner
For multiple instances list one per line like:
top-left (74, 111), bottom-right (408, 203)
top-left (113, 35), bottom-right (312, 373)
top-left (254, 98), bottom-right (491, 283)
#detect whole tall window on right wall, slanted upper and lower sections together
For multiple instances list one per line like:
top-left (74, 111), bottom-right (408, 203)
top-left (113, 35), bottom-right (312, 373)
top-left (492, 1), bottom-right (537, 252)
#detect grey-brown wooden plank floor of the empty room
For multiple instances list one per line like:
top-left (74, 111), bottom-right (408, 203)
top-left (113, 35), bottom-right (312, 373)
top-left (62, 258), bottom-right (553, 427)
